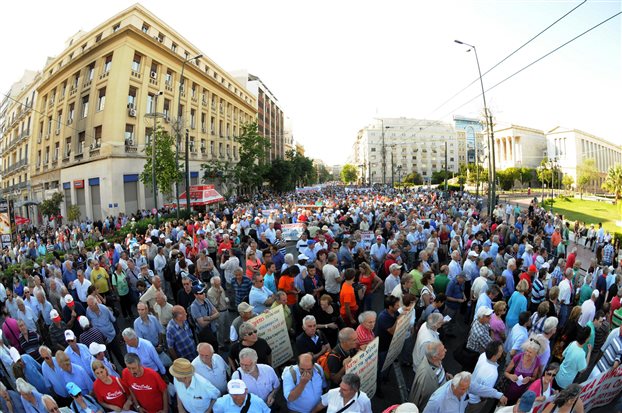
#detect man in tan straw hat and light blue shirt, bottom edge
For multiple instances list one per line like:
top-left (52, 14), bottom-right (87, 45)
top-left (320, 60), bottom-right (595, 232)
top-left (169, 358), bottom-right (220, 413)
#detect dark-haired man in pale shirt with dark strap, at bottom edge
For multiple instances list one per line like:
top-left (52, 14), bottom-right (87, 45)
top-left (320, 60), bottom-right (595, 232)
top-left (312, 373), bottom-right (372, 413)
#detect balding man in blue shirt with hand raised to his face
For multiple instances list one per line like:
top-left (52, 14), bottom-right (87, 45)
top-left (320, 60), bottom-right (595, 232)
top-left (282, 353), bottom-right (326, 413)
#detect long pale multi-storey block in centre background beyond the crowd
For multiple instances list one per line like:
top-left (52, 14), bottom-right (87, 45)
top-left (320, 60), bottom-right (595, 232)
top-left (352, 118), bottom-right (466, 184)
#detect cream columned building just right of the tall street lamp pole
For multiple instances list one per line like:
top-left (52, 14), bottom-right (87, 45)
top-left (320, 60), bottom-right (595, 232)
top-left (495, 125), bottom-right (546, 169)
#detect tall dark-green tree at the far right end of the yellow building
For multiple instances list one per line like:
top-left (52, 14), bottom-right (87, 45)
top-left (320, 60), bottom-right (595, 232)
top-left (235, 122), bottom-right (270, 192)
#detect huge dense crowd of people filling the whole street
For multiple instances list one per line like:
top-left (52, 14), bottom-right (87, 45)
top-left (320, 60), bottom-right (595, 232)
top-left (0, 186), bottom-right (622, 413)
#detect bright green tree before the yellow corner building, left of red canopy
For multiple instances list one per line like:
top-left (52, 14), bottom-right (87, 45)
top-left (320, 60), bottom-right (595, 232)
top-left (140, 127), bottom-right (183, 199)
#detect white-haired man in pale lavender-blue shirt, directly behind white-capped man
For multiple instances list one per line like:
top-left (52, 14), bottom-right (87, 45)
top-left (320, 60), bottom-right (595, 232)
top-left (231, 348), bottom-right (281, 406)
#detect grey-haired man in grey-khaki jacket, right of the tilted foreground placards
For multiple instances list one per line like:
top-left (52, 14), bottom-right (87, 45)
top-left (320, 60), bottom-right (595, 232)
top-left (408, 341), bottom-right (453, 409)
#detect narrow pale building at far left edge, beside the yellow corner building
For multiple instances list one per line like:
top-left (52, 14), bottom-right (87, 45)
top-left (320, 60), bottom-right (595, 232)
top-left (0, 70), bottom-right (41, 223)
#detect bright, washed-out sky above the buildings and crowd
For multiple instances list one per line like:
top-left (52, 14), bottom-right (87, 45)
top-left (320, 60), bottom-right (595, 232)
top-left (0, 0), bottom-right (622, 164)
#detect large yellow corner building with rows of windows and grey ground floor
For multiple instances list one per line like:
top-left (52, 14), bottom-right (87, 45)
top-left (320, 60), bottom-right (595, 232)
top-left (29, 4), bottom-right (257, 219)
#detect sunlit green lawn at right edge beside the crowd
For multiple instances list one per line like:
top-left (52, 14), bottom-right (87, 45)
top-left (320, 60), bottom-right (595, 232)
top-left (553, 198), bottom-right (622, 233)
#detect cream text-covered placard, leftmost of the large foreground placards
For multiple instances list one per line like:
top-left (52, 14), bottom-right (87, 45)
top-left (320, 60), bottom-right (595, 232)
top-left (249, 306), bottom-right (294, 367)
